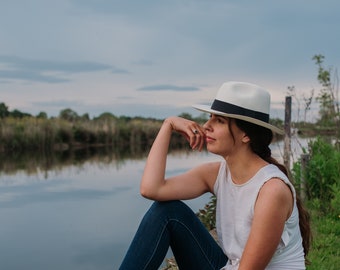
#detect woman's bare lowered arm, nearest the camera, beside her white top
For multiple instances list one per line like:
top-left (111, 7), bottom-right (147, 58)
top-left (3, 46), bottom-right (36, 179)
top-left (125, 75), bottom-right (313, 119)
top-left (239, 178), bottom-right (293, 270)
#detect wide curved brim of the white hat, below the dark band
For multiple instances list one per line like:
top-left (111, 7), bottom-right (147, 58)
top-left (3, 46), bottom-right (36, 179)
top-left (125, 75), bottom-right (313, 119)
top-left (192, 105), bottom-right (284, 135)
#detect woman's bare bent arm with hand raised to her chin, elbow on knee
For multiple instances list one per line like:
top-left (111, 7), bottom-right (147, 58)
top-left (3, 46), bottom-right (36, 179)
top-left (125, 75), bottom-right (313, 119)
top-left (140, 117), bottom-right (216, 201)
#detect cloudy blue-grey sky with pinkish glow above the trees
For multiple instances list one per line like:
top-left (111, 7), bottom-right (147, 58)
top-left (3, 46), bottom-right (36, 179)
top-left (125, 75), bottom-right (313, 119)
top-left (0, 0), bottom-right (340, 120)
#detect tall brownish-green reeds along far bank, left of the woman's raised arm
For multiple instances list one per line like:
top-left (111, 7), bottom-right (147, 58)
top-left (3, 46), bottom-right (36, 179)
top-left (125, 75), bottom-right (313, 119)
top-left (0, 117), bottom-right (165, 153)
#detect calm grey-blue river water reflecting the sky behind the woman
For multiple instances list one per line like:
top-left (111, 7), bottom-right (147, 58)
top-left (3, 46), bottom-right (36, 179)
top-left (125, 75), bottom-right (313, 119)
top-left (0, 137), bottom-right (310, 270)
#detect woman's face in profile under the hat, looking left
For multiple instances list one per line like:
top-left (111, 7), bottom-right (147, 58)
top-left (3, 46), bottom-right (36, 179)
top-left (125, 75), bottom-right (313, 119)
top-left (203, 114), bottom-right (245, 157)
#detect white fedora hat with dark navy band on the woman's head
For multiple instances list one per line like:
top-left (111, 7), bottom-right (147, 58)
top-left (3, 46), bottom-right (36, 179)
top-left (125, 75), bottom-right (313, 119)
top-left (193, 81), bottom-right (284, 134)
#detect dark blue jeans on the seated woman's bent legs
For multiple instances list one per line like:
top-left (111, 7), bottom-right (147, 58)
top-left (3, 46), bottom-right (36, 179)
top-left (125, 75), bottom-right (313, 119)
top-left (119, 201), bottom-right (228, 270)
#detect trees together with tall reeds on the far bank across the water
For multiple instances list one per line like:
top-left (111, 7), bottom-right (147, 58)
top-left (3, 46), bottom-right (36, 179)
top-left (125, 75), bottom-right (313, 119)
top-left (0, 103), bottom-right (212, 155)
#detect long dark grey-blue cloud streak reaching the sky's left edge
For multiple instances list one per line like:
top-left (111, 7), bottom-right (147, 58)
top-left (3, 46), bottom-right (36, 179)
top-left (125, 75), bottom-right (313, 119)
top-left (0, 55), bottom-right (129, 83)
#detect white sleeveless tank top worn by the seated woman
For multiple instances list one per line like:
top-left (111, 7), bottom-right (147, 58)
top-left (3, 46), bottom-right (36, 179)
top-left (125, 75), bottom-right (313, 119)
top-left (214, 161), bottom-right (305, 270)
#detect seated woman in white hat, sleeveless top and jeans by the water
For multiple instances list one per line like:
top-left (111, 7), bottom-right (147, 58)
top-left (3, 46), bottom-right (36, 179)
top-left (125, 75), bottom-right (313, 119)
top-left (120, 82), bottom-right (310, 270)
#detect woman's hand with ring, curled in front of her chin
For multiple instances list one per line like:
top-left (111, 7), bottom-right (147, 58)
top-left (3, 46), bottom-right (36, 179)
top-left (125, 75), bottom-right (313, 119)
top-left (164, 116), bottom-right (205, 151)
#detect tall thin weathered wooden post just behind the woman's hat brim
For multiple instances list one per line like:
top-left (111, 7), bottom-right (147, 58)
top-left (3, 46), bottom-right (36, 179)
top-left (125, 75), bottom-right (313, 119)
top-left (283, 96), bottom-right (292, 173)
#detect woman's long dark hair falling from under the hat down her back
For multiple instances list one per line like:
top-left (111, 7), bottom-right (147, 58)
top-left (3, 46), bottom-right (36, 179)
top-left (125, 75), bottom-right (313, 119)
top-left (229, 119), bottom-right (312, 262)
